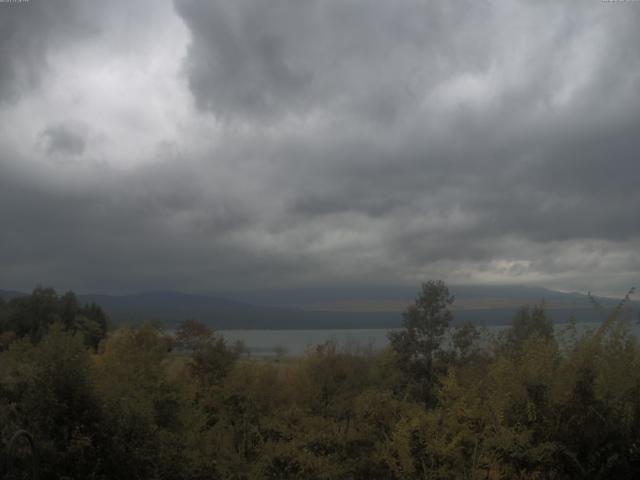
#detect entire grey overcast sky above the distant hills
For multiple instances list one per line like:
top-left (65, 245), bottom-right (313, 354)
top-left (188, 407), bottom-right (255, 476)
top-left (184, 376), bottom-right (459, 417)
top-left (0, 0), bottom-right (640, 293)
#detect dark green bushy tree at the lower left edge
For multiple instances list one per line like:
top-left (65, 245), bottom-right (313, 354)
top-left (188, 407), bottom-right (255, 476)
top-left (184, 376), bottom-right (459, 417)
top-left (0, 323), bottom-right (102, 479)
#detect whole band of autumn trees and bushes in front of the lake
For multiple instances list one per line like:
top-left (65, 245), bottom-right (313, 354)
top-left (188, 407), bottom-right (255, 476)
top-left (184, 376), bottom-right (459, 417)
top-left (0, 281), bottom-right (640, 480)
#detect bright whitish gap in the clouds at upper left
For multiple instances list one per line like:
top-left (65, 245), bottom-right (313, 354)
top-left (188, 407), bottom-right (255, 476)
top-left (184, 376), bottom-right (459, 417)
top-left (3, 1), bottom-right (193, 169)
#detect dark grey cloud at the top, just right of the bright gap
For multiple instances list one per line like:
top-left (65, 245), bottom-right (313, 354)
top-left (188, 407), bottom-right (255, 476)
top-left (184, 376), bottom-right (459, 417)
top-left (175, 0), bottom-right (490, 121)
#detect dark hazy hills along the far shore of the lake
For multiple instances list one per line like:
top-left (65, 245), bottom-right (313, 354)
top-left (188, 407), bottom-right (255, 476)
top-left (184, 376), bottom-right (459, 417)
top-left (0, 286), bottom-right (640, 329)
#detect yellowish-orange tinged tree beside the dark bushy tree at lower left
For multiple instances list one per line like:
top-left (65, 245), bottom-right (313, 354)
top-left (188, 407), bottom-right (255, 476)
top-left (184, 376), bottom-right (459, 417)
top-left (95, 324), bottom-right (205, 480)
